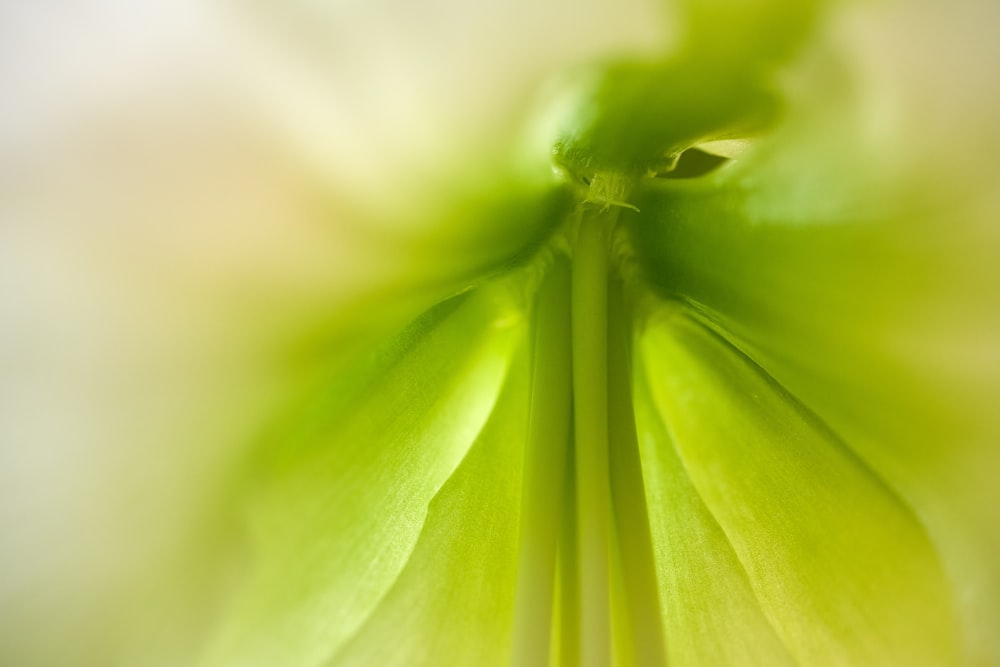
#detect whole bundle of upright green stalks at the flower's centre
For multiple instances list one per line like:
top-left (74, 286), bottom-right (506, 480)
top-left (511, 202), bottom-right (665, 667)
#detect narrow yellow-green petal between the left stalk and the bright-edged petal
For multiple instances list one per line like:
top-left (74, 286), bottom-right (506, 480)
top-left (328, 340), bottom-right (529, 667)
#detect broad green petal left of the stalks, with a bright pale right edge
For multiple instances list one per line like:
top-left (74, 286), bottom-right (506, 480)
top-left (193, 289), bottom-right (518, 667)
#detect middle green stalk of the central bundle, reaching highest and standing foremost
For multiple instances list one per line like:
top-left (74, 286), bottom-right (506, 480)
top-left (572, 206), bottom-right (617, 667)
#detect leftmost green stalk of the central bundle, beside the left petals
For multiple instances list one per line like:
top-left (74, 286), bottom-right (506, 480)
top-left (511, 257), bottom-right (572, 667)
